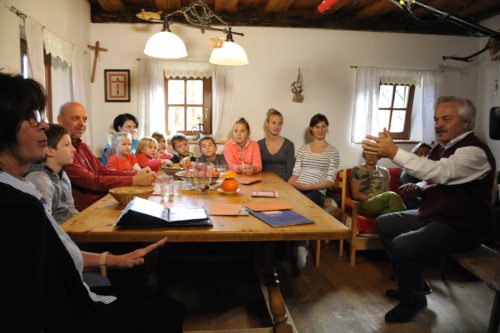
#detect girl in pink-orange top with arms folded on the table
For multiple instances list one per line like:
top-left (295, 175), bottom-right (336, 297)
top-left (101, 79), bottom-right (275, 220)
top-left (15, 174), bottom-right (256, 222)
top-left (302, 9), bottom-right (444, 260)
top-left (224, 118), bottom-right (262, 176)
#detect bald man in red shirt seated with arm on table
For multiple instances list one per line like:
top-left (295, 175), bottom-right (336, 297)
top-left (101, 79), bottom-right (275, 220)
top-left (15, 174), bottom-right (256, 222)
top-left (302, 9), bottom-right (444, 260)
top-left (57, 102), bottom-right (153, 211)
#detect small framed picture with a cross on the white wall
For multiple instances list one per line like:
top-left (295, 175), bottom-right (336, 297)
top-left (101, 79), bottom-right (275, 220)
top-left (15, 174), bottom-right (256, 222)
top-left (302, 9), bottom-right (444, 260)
top-left (104, 69), bottom-right (130, 102)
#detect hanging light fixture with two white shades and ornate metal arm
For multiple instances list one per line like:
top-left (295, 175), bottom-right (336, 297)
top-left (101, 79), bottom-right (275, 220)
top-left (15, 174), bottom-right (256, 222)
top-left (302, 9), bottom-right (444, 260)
top-left (137, 0), bottom-right (248, 66)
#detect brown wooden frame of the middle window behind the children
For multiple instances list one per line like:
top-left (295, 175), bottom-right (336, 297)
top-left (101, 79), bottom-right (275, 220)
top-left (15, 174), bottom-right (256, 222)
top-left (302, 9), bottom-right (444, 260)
top-left (164, 76), bottom-right (213, 135)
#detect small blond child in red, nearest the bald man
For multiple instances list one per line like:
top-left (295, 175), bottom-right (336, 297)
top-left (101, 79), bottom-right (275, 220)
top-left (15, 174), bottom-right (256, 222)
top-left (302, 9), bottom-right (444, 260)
top-left (106, 132), bottom-right (141, 171)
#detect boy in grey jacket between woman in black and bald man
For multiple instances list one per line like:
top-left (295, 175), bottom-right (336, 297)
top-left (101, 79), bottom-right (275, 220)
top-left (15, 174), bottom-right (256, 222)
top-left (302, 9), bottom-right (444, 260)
top-left (26, 124), bottom-right (78, 224)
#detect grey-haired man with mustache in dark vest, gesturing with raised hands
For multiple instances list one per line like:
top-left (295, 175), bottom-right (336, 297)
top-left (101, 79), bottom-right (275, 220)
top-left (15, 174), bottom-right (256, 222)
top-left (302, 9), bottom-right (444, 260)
top-left (363, 97), bottom-right (496, 323)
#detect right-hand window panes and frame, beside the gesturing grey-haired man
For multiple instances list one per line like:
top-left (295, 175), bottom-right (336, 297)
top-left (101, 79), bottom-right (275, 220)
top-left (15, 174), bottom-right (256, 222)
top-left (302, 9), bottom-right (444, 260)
top-left (377, 83), bottom-right (415, 140)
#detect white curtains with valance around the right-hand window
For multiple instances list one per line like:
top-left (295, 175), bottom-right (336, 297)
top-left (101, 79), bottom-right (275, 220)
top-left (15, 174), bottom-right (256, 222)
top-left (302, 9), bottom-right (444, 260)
top-left (351, 67), bottom-right (441, 143)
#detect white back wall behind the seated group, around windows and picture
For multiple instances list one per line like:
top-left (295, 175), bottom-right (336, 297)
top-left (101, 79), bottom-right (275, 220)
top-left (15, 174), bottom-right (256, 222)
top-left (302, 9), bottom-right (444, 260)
top-left (91, 24), bottom-right (479, 166)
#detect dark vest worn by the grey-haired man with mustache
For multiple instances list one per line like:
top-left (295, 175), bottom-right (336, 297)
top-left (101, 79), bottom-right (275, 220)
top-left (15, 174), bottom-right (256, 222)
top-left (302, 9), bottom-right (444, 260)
top-left (418, 133), bottom-right (496, 235)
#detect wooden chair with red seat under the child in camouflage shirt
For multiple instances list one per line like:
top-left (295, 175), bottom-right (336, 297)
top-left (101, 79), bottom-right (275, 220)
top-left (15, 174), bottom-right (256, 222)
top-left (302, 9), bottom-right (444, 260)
top-left (335, 168), bottom-right (401, 265)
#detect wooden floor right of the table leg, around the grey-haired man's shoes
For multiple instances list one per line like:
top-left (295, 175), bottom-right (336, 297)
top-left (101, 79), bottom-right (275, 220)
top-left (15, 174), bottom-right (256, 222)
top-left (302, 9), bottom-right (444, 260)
top-left (280, 244), bottom-right (494, 333)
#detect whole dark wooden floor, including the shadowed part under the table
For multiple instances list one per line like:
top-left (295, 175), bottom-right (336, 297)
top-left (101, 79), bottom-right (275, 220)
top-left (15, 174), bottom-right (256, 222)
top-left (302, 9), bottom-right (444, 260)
top-left (158, 243), bottom-right (494, 333)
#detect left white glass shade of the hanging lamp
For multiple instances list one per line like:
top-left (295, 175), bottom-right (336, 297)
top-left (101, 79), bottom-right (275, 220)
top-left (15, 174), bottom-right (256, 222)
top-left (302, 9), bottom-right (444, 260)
top-left (144, 31), bottom-right (187, 59)
